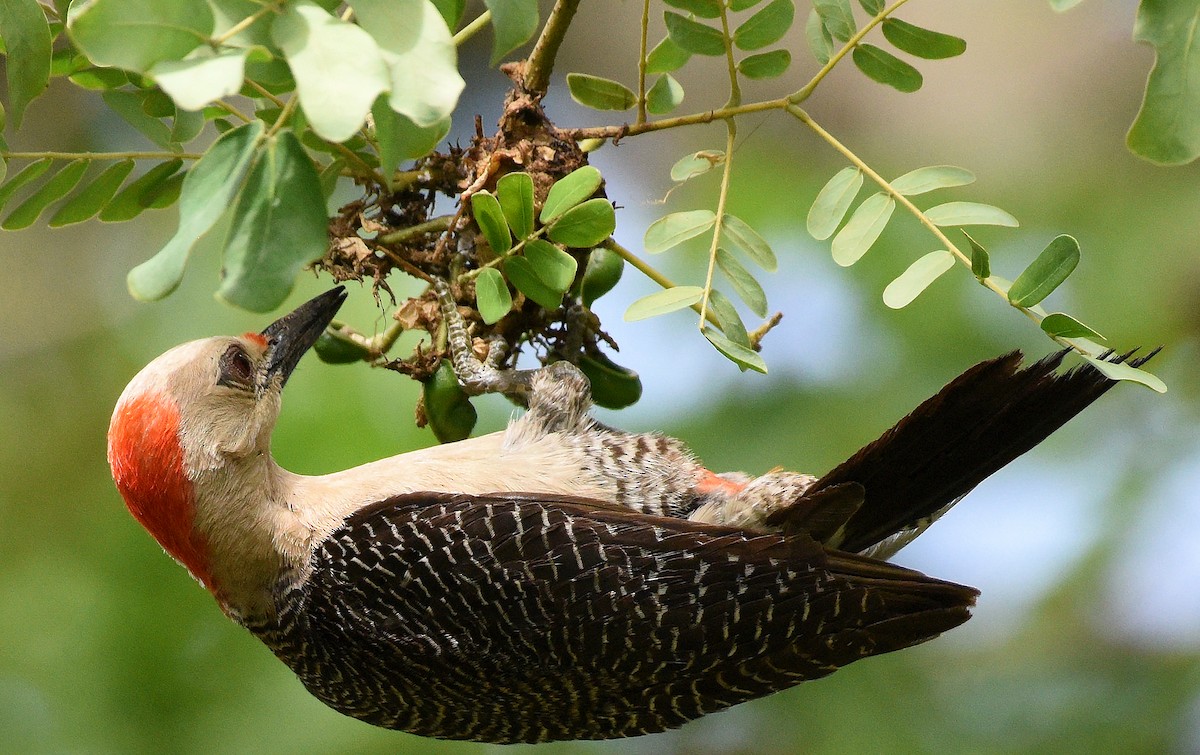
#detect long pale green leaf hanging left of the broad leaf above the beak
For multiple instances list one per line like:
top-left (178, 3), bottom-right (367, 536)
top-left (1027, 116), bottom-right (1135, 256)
top-left (127, 120), bottom-right (264, 301)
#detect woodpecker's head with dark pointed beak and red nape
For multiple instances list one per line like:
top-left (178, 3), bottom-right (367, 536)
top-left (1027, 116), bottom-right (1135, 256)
top-left (108, 286), bottom-right (346, 592)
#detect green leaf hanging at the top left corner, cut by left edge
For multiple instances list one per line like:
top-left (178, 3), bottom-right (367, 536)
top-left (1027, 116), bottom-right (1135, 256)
top-left (0, 0), bottom-right (52, 128)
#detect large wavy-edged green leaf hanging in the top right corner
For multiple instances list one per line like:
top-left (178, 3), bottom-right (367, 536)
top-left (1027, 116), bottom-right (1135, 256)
top-left (1126, 0), bottom-right (1200, 166)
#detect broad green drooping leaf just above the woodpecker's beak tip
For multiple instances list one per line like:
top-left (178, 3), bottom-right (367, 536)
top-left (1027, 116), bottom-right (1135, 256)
top-left (217, 130), bottom-right (329, 312)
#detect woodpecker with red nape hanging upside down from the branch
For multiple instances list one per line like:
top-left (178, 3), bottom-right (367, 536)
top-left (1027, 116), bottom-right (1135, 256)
top-left (108, 287), bottom-right (1152, 743)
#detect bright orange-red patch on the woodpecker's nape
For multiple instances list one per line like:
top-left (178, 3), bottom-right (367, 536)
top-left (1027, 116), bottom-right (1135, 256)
top-left (108, 394), bottom-right (214, 591)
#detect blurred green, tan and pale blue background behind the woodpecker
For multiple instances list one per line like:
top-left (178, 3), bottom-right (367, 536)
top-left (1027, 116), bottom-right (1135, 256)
top-left (0, 0), bottom-right (1200, 753)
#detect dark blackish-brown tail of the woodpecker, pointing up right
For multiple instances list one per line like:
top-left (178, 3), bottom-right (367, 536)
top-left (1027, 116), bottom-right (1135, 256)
top-left (779, 349), bottom-right (1158, 552)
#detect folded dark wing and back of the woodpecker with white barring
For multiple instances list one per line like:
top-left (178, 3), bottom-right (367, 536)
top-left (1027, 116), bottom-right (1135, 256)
top-left (256, 493), bottom-right (977, 742)
